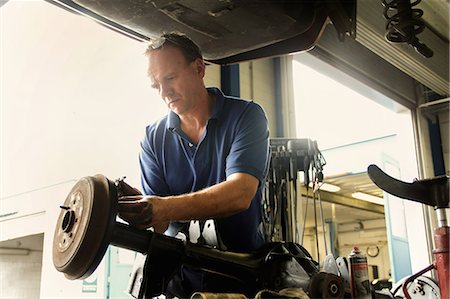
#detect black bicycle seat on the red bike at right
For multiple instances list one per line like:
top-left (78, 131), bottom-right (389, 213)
top-left (367, 164), bottom-right (449, 209)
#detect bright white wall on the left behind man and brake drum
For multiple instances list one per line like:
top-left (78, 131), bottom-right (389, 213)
top-left (0, 1), bottom-right (166, 298)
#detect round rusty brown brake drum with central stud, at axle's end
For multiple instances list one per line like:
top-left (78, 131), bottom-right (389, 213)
top-left (53, 175), bottom-right (117, 279)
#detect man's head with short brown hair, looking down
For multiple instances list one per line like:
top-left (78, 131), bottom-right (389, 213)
top-left (145, 33), bottom-right (207, 116)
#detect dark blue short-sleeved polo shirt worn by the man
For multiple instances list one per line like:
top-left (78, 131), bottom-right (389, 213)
top-left (140, 88), bottom-right (269, 252)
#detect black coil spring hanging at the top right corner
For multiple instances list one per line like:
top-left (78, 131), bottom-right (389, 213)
top-left (382, 0), bottom-right (433, 58)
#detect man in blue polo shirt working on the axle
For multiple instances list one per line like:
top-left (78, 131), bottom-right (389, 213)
top-left (119, 33), bottom-right (269, 298)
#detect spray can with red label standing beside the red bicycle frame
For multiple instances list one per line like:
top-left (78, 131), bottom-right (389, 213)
top-left (348, 246), bottom-right (372, 299)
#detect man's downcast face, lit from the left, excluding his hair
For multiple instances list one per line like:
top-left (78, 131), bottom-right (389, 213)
top-left (148, 47), bottom-right (205, 116)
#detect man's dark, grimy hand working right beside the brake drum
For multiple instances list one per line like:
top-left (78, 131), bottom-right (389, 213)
top-left (119, 195), bottom-right (169, 233)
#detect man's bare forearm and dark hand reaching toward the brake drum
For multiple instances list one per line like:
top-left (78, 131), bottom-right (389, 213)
top-left (119, 173), bottom-right (259, 232)
